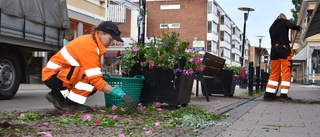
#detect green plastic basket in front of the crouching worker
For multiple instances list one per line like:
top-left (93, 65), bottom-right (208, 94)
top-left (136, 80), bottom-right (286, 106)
top-left (104, 74), bottom-right (145, 107)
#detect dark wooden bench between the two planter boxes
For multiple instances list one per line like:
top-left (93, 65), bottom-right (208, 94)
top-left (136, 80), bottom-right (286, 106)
top-left (195, 52), bottom-right (226, 102)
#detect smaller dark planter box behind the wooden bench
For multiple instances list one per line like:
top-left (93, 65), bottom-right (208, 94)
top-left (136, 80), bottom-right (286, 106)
top-left (202, 70), bottom-right (236, 97)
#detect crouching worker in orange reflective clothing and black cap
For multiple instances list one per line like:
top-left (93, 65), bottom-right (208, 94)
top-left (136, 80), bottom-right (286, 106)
top-left (42, 21), bottom-right (137, 112)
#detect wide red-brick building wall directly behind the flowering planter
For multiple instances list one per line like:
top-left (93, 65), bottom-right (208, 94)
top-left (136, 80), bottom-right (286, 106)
top-left (146, 0), bottom-right (207, 43)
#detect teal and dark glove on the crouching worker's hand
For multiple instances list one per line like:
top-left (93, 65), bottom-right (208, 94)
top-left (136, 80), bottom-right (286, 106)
top-left (110, 85), bottom-right (138, 110)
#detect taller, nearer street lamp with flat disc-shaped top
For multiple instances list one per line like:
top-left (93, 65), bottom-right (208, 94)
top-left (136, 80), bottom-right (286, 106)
top-left (238, 7), bottom-right (254, 67)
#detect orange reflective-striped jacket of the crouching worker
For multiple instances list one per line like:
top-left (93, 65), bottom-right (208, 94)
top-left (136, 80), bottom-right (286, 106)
top-left (42, 34), bottom-right (106, 91)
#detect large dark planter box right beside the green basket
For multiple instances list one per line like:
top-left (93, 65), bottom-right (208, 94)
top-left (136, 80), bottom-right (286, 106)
top-left (130, 59), bottom-right (195, 107)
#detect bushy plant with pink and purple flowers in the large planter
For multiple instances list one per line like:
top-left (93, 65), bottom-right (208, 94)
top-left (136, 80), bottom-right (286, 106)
top-left (116, 30), bottom-right (204, 75)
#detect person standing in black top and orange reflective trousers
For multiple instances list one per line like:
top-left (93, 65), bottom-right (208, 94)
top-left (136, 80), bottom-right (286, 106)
top-left (263, 13), bottom-right (301, 100)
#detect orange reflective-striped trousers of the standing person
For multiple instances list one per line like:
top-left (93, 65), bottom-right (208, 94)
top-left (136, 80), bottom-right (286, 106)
top-left (266, 44), bottom-right (293, 94)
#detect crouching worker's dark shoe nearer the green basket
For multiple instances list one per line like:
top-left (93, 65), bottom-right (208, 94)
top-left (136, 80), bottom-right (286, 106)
top-left (62, 98), bottom-right (91, 112)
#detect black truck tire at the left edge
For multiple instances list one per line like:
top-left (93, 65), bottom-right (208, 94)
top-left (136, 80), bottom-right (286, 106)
top-left (0, 51), bottom-right (21, 100)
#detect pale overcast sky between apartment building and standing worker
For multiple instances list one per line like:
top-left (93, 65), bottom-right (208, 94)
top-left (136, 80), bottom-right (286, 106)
top-left (216, 0), bottom-right (294, 48)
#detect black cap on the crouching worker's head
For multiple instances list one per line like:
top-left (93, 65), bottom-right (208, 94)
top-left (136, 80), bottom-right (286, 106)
top-left (97, 21), bottom-right (123, 42)
